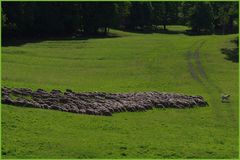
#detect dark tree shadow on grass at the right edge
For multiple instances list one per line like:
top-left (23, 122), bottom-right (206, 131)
top-left (221, 37), bottom-right (239, 63)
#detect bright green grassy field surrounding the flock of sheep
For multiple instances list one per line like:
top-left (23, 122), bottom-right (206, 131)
top-left (2, 27), bottom-right (239, 158)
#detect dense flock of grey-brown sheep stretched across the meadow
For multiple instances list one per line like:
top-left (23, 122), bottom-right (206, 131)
top-left (2, 87), bottom-right (208, 116)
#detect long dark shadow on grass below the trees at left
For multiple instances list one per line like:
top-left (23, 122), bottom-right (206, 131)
top-left (2, 33), bottom-right (120, 47)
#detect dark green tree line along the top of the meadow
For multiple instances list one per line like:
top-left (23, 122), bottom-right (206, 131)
top-left (2, 1), bottom-right (238, 37)
